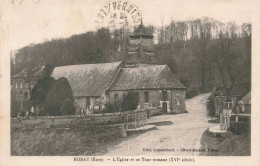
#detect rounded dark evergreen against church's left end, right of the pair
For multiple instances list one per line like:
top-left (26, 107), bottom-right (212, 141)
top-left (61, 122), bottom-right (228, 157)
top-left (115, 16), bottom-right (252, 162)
top-left (44, 77), bottom-right (73, 116)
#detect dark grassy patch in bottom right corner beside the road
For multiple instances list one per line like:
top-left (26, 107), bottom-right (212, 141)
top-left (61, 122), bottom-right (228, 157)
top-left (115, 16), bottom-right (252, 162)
top-left (200, 119), bottom-right (251, 156)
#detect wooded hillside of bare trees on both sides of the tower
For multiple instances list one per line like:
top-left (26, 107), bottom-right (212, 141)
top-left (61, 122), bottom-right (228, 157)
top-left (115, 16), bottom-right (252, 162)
top-left (11, 18), bottom-right (252, 92)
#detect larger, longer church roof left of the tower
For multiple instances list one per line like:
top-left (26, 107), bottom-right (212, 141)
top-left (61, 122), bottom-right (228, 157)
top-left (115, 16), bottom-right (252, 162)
top-left (51, 62), bottom-right (122, 97)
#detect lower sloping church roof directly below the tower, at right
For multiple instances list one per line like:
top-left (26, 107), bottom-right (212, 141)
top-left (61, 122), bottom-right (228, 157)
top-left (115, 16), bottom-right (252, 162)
top-left (108, 65), bottom-right (185, 91)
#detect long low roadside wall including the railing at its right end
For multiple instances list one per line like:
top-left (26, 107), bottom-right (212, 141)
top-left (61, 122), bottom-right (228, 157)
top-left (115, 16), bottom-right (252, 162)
top-left (11, 110), bottom-right (157, 129)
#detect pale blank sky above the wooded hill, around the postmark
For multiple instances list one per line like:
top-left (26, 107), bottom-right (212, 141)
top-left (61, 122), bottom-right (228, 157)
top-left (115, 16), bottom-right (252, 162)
top-left (1, 0), bottom-right (251, 51)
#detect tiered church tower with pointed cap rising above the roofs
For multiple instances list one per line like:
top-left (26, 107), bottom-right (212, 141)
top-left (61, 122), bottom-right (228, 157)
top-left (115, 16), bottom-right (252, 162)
top-left (124, 23), bottom-right (157, 67)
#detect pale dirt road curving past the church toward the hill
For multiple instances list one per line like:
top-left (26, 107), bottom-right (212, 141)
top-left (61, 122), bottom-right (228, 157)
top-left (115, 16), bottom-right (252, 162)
top-left (105, 94), bottom-right (211, 156)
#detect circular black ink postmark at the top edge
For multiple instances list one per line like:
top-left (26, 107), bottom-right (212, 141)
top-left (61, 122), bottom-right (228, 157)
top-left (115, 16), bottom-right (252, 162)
top-left (95, 0), bottom-right (142, 29)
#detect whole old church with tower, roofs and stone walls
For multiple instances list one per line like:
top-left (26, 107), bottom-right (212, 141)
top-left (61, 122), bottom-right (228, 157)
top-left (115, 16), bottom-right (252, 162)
top-left (51, 24), bottom-right (186, 114)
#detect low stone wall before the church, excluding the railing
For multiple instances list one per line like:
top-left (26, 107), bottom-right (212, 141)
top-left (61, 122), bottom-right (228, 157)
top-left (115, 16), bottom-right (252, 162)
top-left (11, 110), bottom-right (150, 128)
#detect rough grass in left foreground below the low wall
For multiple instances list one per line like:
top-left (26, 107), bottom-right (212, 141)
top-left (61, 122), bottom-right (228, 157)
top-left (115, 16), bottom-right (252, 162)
top-left (11, 127), bottom-right (122, 156)
